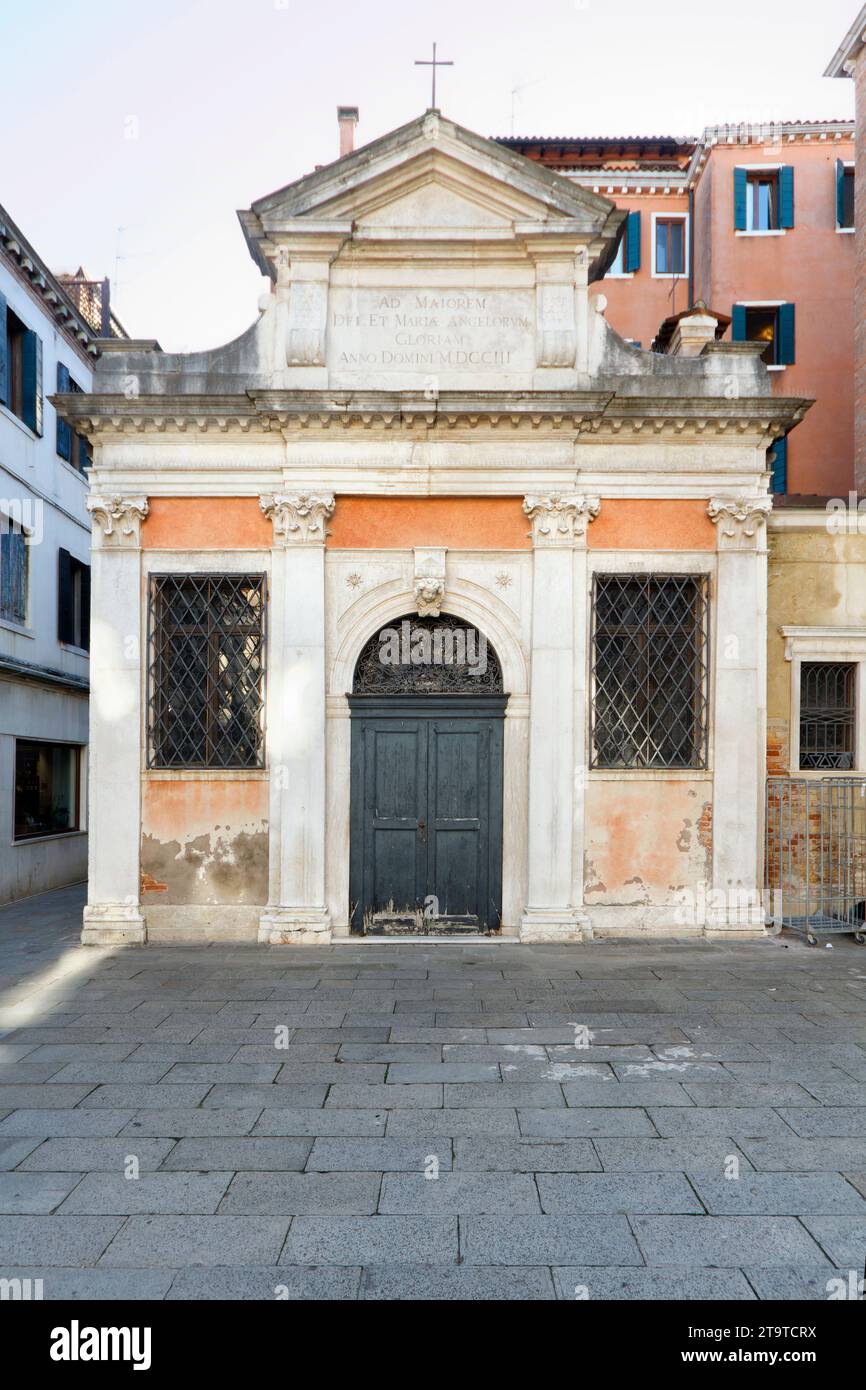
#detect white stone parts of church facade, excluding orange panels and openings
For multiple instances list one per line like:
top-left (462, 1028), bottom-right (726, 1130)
top-left (65, 113), bottom-right (806, 942)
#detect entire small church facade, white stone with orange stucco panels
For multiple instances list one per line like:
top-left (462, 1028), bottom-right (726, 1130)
top-left (57, 110), bottom-right (809, 944)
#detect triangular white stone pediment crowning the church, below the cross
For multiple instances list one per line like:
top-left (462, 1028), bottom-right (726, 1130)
top-left (239, 111), bottom-right (623, 278)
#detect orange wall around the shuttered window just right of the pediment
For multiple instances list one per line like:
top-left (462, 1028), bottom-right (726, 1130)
top-left (589, 193), bottom-right (688, 352)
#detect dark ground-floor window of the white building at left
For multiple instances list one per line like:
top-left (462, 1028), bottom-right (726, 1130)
top-left (15, 738), bottom-right (81, 840)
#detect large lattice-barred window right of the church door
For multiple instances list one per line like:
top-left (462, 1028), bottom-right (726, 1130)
top-left (591, 574), bottom-right (709, 769)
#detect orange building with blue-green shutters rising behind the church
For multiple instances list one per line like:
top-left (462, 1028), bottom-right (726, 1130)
top-left (500, 121), bottom-right (855, 496)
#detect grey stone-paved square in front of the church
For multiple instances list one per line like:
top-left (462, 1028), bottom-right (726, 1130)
top-left (0, 890), bottom-right (866, 1300)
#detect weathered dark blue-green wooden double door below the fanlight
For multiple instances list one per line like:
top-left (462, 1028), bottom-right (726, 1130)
top-left (349, 695), bottom-right (507, 934)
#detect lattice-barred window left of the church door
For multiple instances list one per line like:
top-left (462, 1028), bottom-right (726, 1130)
top-left (147, 574), bottom-right (267, 767)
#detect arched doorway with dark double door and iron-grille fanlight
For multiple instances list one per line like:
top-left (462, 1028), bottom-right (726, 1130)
top-left (349, 613), bottom-right (507, 935)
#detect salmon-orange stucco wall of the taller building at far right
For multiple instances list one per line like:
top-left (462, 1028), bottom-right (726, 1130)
top-left (695, 140), bottom-right (855, 496)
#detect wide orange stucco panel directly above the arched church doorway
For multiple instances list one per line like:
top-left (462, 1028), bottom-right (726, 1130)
top-left (327, 496), bottom-right (531, 550)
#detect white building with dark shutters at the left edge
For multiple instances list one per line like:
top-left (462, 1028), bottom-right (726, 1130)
top-left (0, 207), bottom-right (116, 902)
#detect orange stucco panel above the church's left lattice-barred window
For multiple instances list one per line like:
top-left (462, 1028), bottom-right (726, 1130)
top-left (142, 498), bottom-right (274, 550)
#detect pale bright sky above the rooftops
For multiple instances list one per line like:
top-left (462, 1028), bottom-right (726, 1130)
top-left (0, 0), bottom-right (859, 352)
